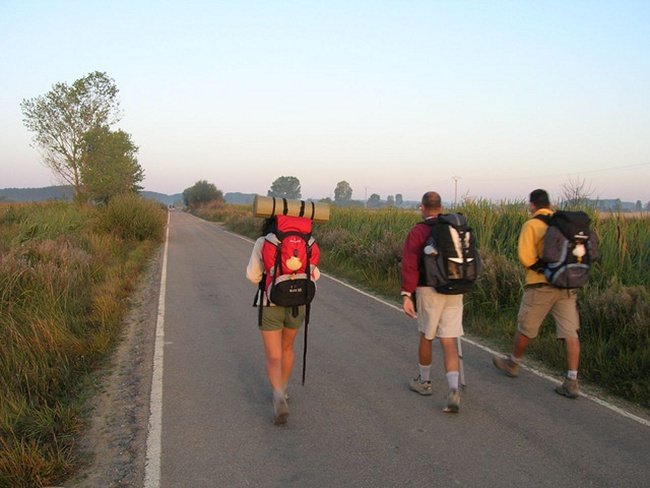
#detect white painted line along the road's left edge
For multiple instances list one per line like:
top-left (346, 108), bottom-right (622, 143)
top-left (144, 212), bottom-right (171, 488)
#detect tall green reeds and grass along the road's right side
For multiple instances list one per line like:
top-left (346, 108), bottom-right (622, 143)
top-left (195, 200), bottom-right (650, 408)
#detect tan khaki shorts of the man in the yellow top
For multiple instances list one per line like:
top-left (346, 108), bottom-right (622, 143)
top-left (517, 285), bottom-right (580, 339)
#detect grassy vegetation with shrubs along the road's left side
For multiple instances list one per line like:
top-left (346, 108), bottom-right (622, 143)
top-left (0, 194), bottom-right (166, 488)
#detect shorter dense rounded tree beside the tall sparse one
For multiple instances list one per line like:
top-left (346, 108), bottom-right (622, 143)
top-left (81, 127), bottom-right (144, 202)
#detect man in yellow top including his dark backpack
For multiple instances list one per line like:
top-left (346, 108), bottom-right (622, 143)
top-left (492, 189), bottom-right (598, 398)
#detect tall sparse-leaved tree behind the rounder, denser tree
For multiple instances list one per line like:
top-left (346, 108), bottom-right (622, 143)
top-left (20, 71), bottom-right (120, 196)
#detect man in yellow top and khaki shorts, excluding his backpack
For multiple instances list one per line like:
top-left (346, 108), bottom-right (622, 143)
top-left (492, 190), bottom-right (580, 398)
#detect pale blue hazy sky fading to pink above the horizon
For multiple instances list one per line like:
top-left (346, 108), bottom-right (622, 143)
top-left (0, 0), bottom-right (650, 203)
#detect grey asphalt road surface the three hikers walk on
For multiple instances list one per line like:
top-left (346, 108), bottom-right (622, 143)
top-left (148, 213), bottom-right (650, 488)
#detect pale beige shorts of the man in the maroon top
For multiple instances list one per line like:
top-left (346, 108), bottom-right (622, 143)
top-left (415, 286), bottom-right (463, 340)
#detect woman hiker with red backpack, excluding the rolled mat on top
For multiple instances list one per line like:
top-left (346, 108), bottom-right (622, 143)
top-left (246, 212), bottom-right (320, 425)
